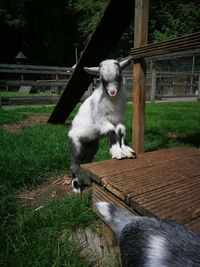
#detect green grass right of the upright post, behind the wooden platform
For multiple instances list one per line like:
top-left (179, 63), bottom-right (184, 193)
top-left (145, 102), bottom-right (200, 151)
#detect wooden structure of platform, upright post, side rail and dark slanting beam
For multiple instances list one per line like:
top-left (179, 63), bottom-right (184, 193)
top-left (49, 0), bottom-right (200, 239)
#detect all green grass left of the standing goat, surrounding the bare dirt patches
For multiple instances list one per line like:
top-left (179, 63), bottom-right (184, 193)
top-left (0, 104), bottom-right (95, 267)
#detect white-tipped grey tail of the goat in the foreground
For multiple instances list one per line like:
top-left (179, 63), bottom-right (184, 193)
top-left (96, 202), bottom-right (132, 237)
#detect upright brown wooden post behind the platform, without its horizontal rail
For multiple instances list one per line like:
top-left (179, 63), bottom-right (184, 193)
top-left (132, 0), bottom-right (149, 153)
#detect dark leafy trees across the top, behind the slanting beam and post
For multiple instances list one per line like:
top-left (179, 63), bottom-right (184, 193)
top-left (0, 0), bottom-right (200, 63)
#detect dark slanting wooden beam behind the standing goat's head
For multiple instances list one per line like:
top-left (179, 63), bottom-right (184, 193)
top-left (48, 0), bottom-right (134, 123)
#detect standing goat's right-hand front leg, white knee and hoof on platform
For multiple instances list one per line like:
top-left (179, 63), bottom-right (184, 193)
top-left (116, 123), bottom-right (136, 158)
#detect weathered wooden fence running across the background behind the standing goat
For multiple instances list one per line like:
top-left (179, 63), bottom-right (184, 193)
top-left (0, 49), bottom-right (200, 105)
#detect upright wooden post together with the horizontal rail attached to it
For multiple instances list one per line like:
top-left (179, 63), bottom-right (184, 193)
top-left (130, 3), bottom-right (200, 153)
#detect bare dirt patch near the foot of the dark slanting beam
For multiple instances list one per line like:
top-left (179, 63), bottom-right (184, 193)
top-left (3, 114), bottom-right (49, 133)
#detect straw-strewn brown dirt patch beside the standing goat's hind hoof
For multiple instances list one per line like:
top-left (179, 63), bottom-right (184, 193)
top-left (19, 174), bottom-right (72, 209)
